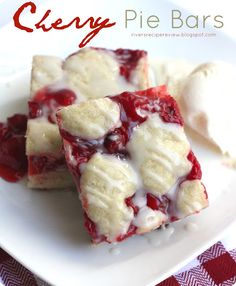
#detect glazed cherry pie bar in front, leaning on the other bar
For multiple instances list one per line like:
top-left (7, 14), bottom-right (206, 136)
top-left (57, 86), bottom-right (208, 243)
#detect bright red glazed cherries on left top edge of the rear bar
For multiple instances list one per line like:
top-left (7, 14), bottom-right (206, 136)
top-left (28, 87), bottom-right (76, 123)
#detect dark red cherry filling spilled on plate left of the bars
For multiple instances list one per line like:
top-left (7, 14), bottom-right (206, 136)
top-left (0, 114), bottom-right (27, 182)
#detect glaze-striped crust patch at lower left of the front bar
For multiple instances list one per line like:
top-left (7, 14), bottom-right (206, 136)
top-left (80, 153), bottom-right (137, 240)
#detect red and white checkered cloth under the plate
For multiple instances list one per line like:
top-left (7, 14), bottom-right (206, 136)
top-left (0, 242), bottom-right (236, 286)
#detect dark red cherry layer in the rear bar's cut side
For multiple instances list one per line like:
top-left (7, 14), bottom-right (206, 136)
top-left (28, 155), bottom-right (66, 176)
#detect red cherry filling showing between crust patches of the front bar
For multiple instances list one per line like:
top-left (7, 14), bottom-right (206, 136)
top-left (58, 86), bottom-right (205, 243)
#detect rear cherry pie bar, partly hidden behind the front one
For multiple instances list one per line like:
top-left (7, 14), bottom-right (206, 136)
top-left (26, 48), bottom-right (148, 189)
